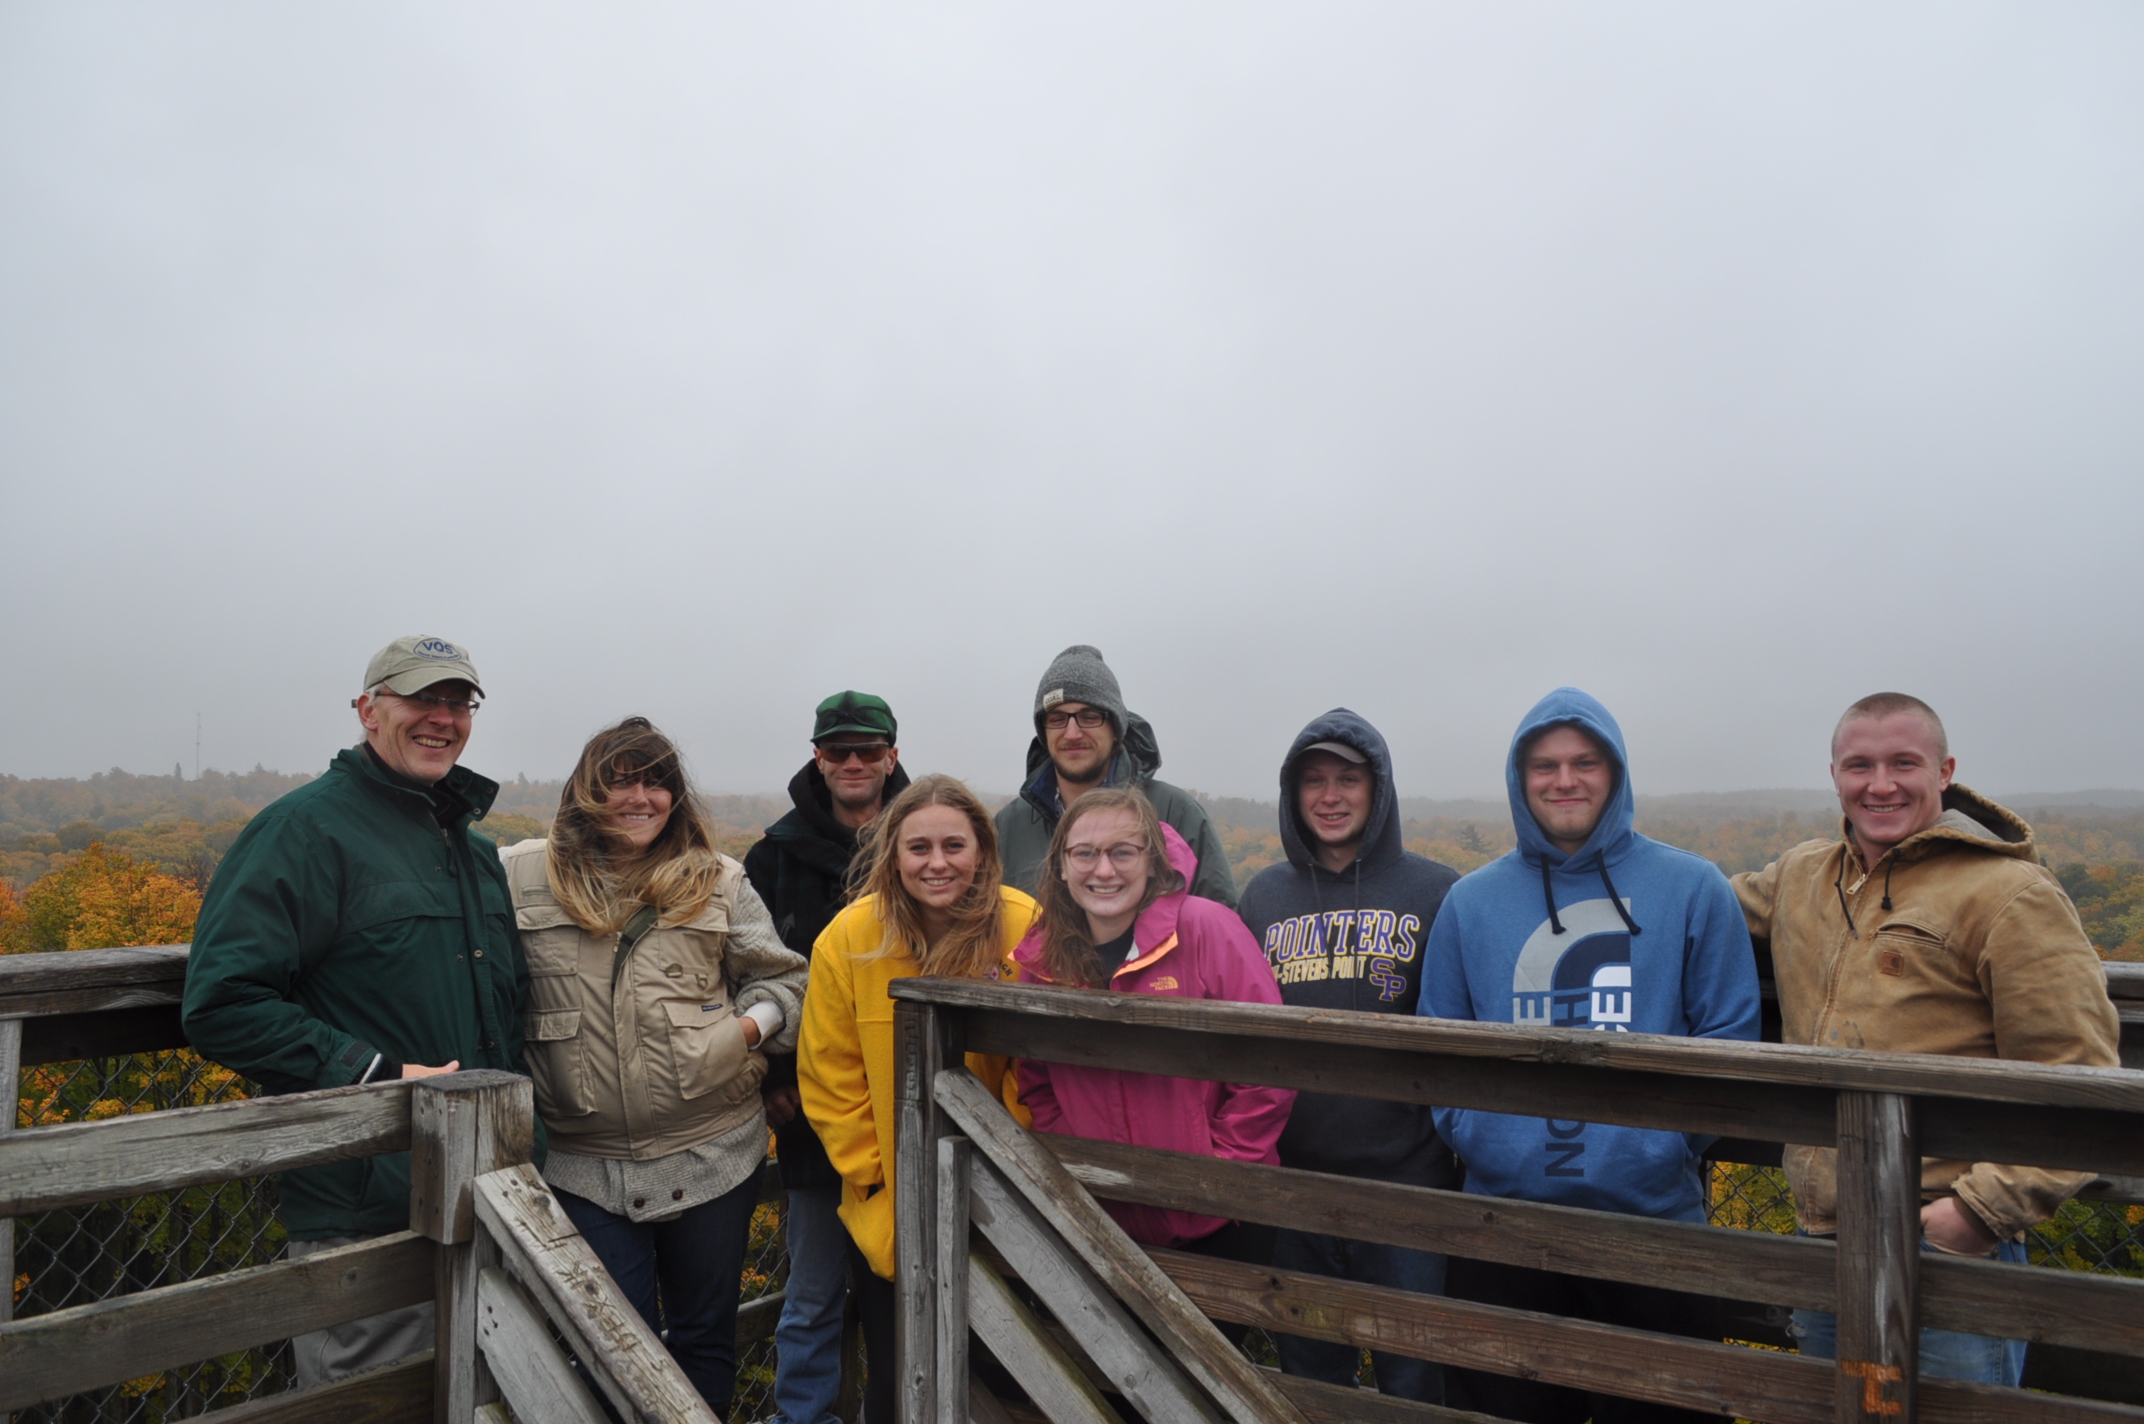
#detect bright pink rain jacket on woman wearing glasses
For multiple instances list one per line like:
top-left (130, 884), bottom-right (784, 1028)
top-left (1012, 821), bottom-right (1295, 1246)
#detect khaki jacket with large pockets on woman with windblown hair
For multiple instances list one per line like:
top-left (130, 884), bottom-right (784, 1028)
top-left (500, 841), bottom-right (806, 1160)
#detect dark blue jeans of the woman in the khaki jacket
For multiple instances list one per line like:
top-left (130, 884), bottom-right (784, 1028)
top-left (551, 1171), bottom-right (759, 1418)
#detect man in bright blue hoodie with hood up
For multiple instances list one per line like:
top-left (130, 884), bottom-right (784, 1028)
top-left (1417, 688), bottom-right (1758, 1424)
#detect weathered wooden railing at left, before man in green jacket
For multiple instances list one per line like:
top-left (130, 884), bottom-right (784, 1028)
top-left (0, 946), bottom-right (728, 1424)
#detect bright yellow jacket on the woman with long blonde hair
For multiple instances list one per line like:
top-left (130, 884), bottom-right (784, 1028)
top-left (798, 886), bottom-right (1036, 1280)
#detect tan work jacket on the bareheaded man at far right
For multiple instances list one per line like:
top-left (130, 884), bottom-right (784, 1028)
top-left (1734, 785), bottom-right (2120, 1237)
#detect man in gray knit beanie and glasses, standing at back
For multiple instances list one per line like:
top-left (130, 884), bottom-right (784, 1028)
top-left (997, 643), bottom-right (1235, 909)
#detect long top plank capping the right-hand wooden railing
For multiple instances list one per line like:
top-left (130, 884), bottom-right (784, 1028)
top-left (890, 978), bottom-right (2144, 1122)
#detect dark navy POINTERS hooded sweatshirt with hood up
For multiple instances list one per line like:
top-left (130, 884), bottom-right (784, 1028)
top-left (1244, 708), bottom-right (1458, 1186)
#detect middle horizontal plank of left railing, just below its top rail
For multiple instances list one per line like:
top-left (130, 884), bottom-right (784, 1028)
top-left (0, 1231), bottom-right (433, 1409)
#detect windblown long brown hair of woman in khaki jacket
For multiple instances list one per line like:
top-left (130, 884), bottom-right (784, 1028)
top-left (545, 716), bottom-right (723, 935)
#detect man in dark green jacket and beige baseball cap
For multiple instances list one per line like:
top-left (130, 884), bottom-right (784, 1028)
top-left (184, 637), bottom-right (540, 1383)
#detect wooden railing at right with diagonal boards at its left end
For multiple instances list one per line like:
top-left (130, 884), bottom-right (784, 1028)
top-left (892, 980), bottom-right (2144, 1424)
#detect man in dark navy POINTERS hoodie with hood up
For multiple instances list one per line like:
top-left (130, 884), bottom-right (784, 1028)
top-left (1241, 708), bottom-right (1458, 1405)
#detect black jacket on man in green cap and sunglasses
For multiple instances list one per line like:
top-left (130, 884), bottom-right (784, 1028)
top-left (744, 759), bottom-right (909, 1188)
